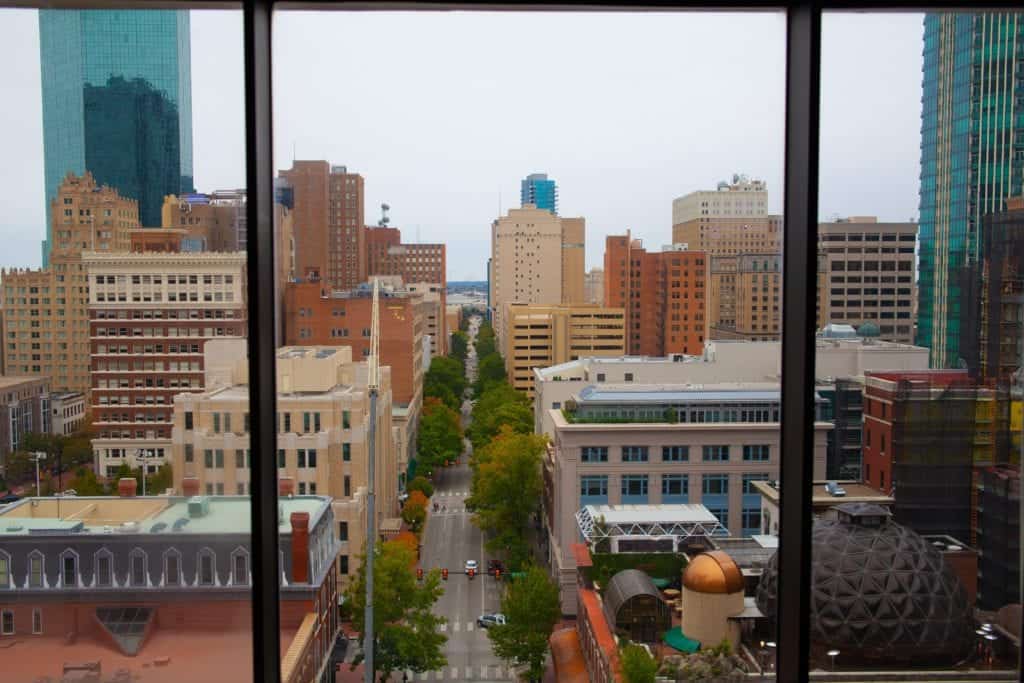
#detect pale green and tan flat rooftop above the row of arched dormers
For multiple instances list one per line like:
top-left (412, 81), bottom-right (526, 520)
top-left (0, 496), bottom-right (331, 538)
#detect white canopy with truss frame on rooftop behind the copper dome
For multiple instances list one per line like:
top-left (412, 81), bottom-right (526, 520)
top-left (575, 504), bottom-right (729, 552)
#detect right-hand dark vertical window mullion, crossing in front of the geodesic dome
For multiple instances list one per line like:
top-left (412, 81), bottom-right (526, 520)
top-left (776, 2), bottom-right (821, 681)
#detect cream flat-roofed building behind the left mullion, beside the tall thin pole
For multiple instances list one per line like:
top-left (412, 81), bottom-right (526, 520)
top-left (172, 340), bottom-right (398, 575)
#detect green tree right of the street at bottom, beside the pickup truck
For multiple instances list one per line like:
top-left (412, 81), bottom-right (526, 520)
top-left (487, 566), bottom-right (561, 681)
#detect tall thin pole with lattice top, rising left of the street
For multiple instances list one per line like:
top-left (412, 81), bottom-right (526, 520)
top-left (362, 278), bottom-right (380, 683)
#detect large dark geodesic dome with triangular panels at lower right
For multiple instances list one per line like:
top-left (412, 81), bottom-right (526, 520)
top-left (757, 503), bottom-right (973, 661)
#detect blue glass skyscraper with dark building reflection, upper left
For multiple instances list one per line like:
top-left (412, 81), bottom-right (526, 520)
top-left (39, 9), bottom-right (193, 265)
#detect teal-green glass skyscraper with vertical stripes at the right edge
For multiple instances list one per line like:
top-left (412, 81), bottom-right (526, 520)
top-left (916, 12), bottom-right (1024, 368)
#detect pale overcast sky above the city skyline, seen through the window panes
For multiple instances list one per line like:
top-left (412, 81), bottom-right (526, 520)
top-left (0, 10), bottom-right (922, 280)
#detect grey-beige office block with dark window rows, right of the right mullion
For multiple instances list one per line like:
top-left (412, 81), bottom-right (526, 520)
top-left (818, 216), bottom-right (918, 344)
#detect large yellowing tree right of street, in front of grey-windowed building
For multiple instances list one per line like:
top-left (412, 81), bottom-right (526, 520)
top-left (466, 425), bottom-right (547, 570)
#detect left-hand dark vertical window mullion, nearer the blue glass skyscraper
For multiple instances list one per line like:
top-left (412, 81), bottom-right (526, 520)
top-left (243, 0), bottom-right (281, 683)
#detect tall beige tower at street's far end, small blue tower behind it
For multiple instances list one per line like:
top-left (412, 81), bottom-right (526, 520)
top-left (488, 204), bottom-right (586, 348)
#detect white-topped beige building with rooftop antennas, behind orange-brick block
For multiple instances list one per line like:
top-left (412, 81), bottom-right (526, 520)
top-left (672, 175), bottom-right (782, 256)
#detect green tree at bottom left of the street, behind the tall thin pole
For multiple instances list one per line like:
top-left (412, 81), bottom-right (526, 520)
top-left (348, 541), bottom-right (447, 682)
